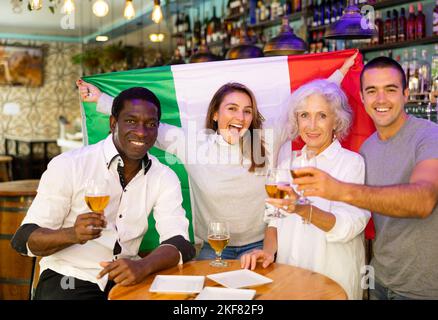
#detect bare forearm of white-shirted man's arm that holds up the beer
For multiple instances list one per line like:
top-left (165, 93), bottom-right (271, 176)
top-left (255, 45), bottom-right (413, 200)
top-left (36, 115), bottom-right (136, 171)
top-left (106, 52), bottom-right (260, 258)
top-left (27, 228), bottom-right (78, 257)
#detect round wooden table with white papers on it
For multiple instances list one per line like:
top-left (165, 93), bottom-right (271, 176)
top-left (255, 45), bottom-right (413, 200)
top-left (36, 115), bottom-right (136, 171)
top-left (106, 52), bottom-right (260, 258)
top-left (108, 260), bottom-right (347, 300)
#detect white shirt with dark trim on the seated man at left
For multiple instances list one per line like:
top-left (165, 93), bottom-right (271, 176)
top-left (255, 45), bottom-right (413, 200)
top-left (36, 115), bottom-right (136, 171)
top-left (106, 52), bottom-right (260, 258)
top-left (22, 135), bottom-right (189, 290)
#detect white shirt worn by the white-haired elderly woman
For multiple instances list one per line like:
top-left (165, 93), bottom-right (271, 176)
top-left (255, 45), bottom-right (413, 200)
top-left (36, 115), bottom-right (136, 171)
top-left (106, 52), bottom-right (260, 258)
top-left (269, 140), bottom-right (371, 299)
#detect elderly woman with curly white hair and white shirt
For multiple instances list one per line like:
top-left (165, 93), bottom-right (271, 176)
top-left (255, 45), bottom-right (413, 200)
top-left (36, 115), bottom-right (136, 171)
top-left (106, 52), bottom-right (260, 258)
top-left (241, 80), bottom-right (370, 299)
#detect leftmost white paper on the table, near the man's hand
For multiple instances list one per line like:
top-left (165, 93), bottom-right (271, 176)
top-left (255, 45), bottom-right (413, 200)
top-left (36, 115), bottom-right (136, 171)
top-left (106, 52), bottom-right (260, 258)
top-left (149, 275), bottom-right (205, 293)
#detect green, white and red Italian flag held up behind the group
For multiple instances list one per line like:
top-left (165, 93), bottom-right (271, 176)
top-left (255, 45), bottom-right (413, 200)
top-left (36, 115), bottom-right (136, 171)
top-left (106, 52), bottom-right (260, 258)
top-left (82, 50), bottom-right (374, 250)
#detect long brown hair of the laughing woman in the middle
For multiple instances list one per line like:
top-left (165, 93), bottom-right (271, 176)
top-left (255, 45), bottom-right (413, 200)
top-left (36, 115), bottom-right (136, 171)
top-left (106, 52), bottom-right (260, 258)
top-left (205, 82), bottom-right (266, 172)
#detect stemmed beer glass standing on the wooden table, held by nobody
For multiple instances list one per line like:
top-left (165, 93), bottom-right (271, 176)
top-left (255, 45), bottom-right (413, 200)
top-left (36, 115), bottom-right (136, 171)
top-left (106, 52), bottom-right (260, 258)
top-left (208, 221), bottom-right (230, 267)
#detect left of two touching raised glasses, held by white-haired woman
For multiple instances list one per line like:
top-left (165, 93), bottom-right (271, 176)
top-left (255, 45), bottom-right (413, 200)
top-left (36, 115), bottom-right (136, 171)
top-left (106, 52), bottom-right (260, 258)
top-left (265, 168), bottom-right (291, 218)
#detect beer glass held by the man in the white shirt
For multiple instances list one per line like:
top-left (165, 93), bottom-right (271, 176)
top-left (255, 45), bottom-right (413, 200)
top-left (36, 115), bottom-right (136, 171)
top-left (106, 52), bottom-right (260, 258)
top-left (85, 179), bottom-right (110, 228)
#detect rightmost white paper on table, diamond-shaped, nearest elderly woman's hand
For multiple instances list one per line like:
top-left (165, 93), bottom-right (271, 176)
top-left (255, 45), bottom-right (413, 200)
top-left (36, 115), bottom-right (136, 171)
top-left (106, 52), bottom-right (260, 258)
top-left (207, 269), bottom-right (272, 289)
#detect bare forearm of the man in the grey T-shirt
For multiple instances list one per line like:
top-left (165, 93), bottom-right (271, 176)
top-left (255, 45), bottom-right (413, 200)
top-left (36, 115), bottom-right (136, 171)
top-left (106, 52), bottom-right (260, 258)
top-left (338, 182), bottom-right (438, 218)
